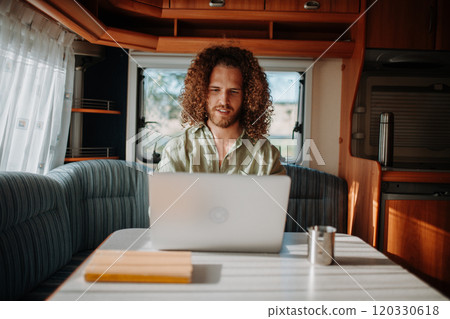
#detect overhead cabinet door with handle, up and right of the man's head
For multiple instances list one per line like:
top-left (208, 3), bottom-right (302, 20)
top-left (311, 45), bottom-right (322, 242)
top-left (266, 0), bottom-right (359, 13)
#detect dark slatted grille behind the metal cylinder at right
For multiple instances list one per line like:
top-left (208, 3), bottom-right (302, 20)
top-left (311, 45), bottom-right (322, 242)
top-left (370, 85), bottom-right (450, 150)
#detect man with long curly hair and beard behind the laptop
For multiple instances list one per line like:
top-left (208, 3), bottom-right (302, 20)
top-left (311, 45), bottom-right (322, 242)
top-left (158, 46), bottom-right (286, 175)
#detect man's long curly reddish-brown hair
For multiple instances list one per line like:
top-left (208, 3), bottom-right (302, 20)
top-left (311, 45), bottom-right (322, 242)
top-left (180, 46), bottom-right (273, 139)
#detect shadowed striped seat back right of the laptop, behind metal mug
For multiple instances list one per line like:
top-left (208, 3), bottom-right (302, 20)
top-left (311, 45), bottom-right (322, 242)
top-left (285, 164), bottom-right (348, 232)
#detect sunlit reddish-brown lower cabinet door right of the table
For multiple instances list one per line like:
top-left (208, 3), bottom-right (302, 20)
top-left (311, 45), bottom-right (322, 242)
top-left (384, 199), bottom-right (450, 292)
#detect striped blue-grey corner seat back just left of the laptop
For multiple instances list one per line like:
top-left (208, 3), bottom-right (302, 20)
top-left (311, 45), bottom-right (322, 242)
top-left (47, 160), bottom-right (149, 252)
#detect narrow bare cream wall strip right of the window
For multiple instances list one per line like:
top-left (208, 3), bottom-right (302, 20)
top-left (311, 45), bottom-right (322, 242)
top-left (309, 59), bottom-right (342, 175)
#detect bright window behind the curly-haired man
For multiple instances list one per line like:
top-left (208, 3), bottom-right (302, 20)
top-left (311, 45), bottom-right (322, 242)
top-left (127, 54), bottom-right (309, 162)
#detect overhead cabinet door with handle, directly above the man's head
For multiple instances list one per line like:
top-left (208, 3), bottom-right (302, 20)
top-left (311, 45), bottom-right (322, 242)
top-left (170, 0), bottom-right (264, 10)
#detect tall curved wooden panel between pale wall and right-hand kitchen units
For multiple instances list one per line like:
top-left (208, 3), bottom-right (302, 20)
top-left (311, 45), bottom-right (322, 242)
top-left (339, 3), bottom-right (381, 246)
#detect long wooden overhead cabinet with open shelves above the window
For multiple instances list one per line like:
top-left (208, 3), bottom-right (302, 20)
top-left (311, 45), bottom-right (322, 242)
top-left (26, 0), bottom-right (365, 58)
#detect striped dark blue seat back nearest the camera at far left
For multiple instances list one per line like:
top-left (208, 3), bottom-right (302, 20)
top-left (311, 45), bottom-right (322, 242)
top-left (0, 172), bottom-right (72, 300)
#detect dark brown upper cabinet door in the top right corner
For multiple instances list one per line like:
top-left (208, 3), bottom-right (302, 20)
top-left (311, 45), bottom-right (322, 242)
top-left (366, 0), bottom-right (435, 50)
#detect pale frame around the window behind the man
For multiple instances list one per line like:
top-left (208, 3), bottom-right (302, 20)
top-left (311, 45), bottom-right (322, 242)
top-left (126, 50), bottom-right (314, 167)
